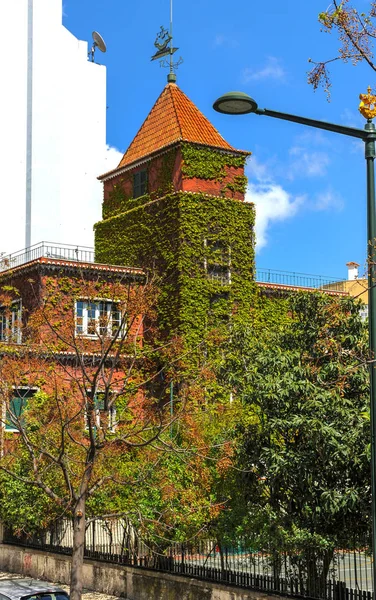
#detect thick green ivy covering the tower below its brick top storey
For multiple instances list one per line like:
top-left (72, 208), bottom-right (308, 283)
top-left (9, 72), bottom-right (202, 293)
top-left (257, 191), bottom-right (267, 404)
top-left (95, 192), bottom-right (256, 346)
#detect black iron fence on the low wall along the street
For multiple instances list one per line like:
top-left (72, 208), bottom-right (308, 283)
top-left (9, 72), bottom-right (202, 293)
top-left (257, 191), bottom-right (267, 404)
top-left (4, 519), bottom-right (373, 600)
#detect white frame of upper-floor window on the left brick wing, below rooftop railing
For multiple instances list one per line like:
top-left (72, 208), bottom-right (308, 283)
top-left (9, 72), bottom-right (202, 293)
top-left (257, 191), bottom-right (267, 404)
top-left (74, 298), bottom-right (126, 339)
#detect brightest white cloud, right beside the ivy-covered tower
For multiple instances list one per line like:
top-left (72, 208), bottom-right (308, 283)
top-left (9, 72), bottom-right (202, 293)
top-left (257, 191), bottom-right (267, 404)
top-left (245, 182), bottom-right (304, 250)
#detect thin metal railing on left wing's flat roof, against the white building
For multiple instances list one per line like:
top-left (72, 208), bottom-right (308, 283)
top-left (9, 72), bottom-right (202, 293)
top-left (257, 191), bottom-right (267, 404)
top-left (0, 242), bottom-right (94, 271)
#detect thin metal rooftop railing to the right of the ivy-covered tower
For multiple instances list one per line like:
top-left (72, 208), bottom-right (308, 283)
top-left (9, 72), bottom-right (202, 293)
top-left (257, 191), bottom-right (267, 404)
top-left (256, 269), bottom-right (344, 292)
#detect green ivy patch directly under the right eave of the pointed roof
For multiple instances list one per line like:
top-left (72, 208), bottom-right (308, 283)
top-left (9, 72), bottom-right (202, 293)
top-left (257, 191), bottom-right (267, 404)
top-left (181, 144), bottom-right (247, 181)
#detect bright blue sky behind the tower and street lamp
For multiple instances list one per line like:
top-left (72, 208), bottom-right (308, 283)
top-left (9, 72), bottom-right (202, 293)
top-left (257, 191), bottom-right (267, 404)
top-left (64, 0), bottom-right (373, 277)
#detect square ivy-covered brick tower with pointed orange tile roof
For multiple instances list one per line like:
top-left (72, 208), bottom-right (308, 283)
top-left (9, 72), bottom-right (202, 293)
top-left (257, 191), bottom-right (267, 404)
top-left (95, 81), bottom-right (255, 345)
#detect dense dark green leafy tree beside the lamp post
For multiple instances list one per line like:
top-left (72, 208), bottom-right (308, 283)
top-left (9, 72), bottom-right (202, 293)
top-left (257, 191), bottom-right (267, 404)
top-left (224, 293), bottom-right (370, 592)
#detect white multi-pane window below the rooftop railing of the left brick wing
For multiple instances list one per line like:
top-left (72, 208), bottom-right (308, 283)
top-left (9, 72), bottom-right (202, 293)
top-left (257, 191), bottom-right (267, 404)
top-left (76, 300), bottom-right (122, 338)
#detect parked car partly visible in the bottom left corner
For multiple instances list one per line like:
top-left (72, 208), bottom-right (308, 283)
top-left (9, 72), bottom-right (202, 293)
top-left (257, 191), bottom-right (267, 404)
top-left (0, 577), bottom-right (69, 600)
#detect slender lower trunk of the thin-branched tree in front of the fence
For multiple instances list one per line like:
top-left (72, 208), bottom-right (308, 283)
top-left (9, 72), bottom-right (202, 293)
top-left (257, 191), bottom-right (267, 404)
top-left (70, 496), bottom-right (86, 600)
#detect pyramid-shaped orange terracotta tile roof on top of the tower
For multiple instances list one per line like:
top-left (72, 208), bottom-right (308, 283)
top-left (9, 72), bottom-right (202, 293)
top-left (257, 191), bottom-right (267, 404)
top-left (117, 83), bottom-right (239, 168)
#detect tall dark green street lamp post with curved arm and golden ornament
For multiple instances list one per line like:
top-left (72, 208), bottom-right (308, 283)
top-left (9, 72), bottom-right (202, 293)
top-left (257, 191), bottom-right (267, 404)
top-left (213, 88), bottom-right (376, 594)
